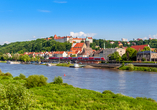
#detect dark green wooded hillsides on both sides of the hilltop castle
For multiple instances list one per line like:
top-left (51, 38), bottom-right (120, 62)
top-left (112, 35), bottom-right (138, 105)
top-left (0, 37), bottom-right (157, 54)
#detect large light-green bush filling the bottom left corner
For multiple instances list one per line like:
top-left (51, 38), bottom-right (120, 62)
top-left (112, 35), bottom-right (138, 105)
top-left (0, 84), bottom-right (34, 110)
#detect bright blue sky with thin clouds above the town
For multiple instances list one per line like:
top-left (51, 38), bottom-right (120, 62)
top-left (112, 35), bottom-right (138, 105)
top-left (0, 0), bottom-right (157, 44)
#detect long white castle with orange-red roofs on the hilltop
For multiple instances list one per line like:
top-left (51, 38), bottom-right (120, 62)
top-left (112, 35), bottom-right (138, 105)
top-left (54, 35), bottom-right (93, 43)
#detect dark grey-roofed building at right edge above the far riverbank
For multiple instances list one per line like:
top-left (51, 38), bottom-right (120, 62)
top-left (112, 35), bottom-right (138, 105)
top-left (136, 51), bottom-right (157, 61)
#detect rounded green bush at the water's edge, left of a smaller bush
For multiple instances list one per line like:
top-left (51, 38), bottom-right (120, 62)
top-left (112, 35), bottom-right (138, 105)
top-left (25, 75), bottom-right (47, 88)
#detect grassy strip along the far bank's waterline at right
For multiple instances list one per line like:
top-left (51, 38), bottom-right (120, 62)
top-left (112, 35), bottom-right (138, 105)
top-left (119, 65), bottom-right (157, 72)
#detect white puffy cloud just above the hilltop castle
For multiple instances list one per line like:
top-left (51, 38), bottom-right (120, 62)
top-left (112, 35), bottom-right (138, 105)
top-left (70, 31), bottom-right (96, 37)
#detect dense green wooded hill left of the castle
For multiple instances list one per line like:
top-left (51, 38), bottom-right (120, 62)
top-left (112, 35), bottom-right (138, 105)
top-left (0, 39), bottom-right (71, 54)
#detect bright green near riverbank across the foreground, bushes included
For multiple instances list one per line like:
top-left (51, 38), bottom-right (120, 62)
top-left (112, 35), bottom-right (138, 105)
top-left (0, 72), bottom-right (157, 110)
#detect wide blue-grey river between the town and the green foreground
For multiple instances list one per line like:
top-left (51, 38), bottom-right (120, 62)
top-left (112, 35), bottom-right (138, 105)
top-left (0, 63), bottom-right (157, 101)
